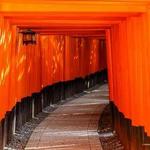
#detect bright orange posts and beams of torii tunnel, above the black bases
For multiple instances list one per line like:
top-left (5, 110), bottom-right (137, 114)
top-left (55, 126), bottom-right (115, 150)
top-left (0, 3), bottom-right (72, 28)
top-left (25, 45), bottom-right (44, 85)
top-left (0, 0), bottom-right (150, 147)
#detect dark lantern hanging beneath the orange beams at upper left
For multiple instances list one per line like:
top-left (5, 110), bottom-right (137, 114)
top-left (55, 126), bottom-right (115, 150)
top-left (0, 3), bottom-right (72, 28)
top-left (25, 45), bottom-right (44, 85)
top-left (21, 29), bottom-right (36, 45)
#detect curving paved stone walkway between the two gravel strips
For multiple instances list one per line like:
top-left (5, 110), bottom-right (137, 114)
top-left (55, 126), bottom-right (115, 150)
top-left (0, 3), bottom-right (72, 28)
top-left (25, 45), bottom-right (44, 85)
top-left (25, 85), bottom-right (109, 150)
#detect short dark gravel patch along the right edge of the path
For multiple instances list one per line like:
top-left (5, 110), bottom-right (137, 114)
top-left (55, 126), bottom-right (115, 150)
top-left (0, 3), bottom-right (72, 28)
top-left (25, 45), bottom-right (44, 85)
top-left (98, 105), bottom-right (124, 150)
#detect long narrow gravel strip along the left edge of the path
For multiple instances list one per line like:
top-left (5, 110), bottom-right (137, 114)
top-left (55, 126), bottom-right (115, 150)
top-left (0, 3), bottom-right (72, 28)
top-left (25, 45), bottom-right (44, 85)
top-left (5, 85), bottom-right (100, 150)
